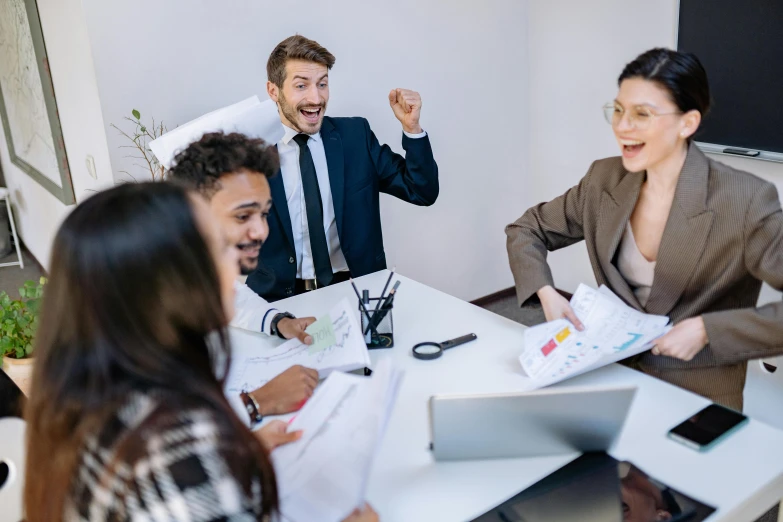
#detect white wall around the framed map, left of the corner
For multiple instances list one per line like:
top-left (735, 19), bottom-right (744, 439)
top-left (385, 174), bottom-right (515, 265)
top-left (0, 0), bottom-right (113, 270)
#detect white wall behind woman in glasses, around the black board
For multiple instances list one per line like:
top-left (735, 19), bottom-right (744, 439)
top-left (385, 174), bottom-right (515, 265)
top-left (528, 0), bottom-right (783, 301)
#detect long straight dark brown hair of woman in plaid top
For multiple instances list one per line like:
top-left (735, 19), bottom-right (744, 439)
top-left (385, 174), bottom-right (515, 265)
top-left (24, 183), bottom-right (278, 522)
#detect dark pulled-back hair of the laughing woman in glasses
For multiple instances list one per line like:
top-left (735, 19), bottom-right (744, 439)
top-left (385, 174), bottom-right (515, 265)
top-left (617, 48), bottom-right (710, 117)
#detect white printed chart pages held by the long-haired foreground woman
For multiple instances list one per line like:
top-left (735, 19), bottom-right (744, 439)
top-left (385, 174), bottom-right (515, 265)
top-left (272, 361), bottom-right (402, 522)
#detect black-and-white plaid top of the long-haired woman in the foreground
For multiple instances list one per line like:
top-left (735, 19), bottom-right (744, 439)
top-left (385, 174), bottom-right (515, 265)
top-left (63, 394), bottom-right (270, 522)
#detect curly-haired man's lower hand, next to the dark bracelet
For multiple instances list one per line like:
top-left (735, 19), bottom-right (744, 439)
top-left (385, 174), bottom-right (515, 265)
top-left (250, 364), bottom-right (318, 416)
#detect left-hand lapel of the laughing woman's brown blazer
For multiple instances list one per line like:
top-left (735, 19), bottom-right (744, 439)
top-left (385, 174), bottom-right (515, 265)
top-left (595, 172), bottom-right (645, 310)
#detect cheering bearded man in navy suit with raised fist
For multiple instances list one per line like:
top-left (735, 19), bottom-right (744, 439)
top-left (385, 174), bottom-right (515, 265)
top-left (247, 35), bottom-right (438, 301)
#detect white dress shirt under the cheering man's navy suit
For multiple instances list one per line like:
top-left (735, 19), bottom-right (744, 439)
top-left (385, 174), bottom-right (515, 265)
top-left (277, 125), bottom-right (427, 279)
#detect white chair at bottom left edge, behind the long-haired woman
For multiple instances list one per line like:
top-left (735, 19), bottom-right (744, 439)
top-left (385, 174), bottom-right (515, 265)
top-left (0, 417), bottom-right (25, 522)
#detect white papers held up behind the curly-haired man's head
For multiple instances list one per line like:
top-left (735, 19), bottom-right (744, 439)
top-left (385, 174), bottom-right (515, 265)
top-left (149, 96), bottom-right (284, 169)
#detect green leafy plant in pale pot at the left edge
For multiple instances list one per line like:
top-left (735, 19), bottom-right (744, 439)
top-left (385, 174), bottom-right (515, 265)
top-left (0, 277), bottom-right (46, 395)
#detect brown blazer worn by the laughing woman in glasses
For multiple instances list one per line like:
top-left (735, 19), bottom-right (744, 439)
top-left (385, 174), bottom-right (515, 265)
top-left (506, 145), bottom-right (783, 408)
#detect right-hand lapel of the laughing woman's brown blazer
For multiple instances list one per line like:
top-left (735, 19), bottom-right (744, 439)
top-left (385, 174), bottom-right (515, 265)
top-left (646, 140), bottom-right (713, 315)
